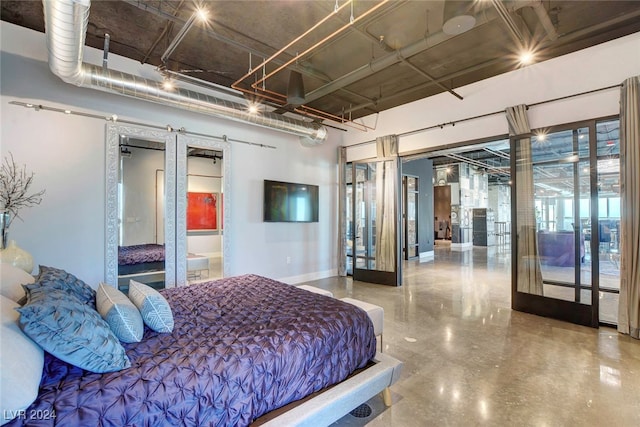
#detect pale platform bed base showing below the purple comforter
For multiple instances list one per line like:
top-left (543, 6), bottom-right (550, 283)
top-left (252, 352), bottom-right (402, 427)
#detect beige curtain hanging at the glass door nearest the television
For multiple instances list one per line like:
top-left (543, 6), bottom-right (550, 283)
top-left (375, 135), bottom-right (398, 271)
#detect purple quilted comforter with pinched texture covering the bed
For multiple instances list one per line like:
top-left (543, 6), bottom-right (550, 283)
top-left (14, 275), bottom-right (376, 427)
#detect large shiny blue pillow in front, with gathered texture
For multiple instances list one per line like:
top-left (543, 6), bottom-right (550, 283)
top-left (16, 286), bottom-right (131, 373)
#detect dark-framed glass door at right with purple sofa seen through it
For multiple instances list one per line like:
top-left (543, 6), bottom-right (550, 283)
top-left (511, 119), bottom-right (620, 327)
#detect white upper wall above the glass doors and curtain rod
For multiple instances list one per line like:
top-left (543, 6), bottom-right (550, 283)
top-left (343, 33), bottom-right (640, 160)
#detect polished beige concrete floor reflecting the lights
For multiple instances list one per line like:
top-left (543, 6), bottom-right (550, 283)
top-left (307, 247), bottom-right (640, 427)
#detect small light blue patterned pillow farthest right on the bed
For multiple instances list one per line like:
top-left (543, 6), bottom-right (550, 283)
top-left (129, 280), bottom-right (173, 332)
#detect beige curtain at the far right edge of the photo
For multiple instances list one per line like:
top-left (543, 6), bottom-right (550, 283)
top-left (618, 76), bottom-right (640, 339)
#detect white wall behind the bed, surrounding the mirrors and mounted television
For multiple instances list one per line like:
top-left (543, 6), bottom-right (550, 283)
top-left (0, 22), bottom-right (340, 286)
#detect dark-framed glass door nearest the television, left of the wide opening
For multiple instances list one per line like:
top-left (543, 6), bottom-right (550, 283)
top-left (347, 159), bottom-right (401, 286)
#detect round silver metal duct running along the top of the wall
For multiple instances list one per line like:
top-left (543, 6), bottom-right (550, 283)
top-left (42, 0), bottom-right (327, 146)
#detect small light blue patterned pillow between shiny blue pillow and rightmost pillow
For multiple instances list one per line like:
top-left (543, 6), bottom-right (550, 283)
top-left (96, 283), bottom-right (144, 342)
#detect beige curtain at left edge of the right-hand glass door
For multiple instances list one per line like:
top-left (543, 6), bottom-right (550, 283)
top-left (506, 105), bottom-right (543, 295)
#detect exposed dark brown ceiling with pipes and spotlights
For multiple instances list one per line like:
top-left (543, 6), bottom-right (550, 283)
top-left (1, 0), bottom-right (640, 127)
